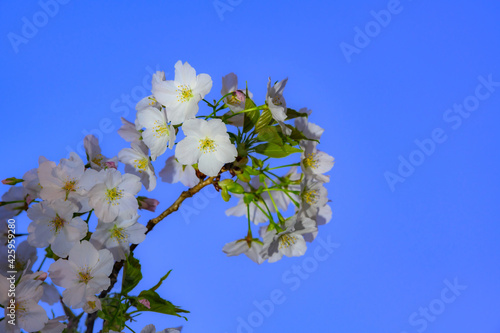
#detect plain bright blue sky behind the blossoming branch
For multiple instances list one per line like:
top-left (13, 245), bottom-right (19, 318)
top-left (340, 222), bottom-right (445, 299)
top-left (0, 0), bottom-right (500, 333)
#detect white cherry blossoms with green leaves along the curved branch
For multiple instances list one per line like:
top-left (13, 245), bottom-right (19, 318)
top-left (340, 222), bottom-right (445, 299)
top-left (0, 61), bottom-right (334, 333)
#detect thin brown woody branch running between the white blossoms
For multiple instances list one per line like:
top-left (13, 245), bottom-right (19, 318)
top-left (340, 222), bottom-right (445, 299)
top-left (85, 175), bottom-right (217, 333)
